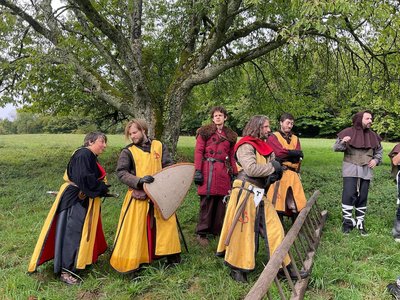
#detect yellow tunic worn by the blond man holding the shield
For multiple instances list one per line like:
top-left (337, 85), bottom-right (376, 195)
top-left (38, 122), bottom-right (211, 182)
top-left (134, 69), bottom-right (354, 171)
top-left (110, 140), bottom-right (181, 273)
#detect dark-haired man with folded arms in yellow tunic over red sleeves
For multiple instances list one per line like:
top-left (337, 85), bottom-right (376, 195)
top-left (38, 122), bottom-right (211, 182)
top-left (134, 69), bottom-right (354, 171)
top-left (267, 113), bottom-right (307, 220)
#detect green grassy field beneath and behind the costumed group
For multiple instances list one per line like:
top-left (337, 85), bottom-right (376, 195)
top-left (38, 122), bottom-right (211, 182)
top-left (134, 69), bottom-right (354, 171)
top-left (0, 135), bottom-right (400, 300)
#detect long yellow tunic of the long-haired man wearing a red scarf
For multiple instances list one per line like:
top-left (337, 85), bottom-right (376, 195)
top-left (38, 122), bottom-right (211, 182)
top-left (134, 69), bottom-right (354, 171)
top-left (217, 152), bottom-right (290, 271)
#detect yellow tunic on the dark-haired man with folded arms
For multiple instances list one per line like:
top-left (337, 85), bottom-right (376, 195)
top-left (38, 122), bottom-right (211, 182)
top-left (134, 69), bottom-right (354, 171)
top-left (267, 132), bottom-right (307, 212)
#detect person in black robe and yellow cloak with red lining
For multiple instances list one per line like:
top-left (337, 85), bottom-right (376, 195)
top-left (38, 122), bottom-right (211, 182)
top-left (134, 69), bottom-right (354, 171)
top-left (28, 132), bottom-right (108, 284)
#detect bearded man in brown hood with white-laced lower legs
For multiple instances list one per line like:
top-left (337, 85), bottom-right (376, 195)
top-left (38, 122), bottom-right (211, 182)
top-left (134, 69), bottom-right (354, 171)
top-left (333, 110), bottom-right (383, 236)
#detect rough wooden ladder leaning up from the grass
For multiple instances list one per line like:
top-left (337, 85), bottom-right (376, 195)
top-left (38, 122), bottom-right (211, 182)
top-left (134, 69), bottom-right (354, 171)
top-left (245, 191), bottom-right (328, 300)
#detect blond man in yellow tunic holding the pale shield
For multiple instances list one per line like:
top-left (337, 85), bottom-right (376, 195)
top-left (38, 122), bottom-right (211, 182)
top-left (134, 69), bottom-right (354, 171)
top-left (110, 119), bottom-right (181, 273)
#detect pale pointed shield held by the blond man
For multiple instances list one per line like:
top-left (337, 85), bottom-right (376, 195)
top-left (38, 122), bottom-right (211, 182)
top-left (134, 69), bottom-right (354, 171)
top-left (143, 163), bottom-right (195, 220)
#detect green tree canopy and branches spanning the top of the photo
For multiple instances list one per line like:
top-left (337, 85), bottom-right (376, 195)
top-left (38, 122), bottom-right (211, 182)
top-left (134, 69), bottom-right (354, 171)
top-left (0, 0), bottom-right (400, 152)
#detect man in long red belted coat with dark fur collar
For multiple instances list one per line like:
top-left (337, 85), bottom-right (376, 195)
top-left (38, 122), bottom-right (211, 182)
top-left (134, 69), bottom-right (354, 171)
top-left (194, 106), bottom-right (237, 246)
